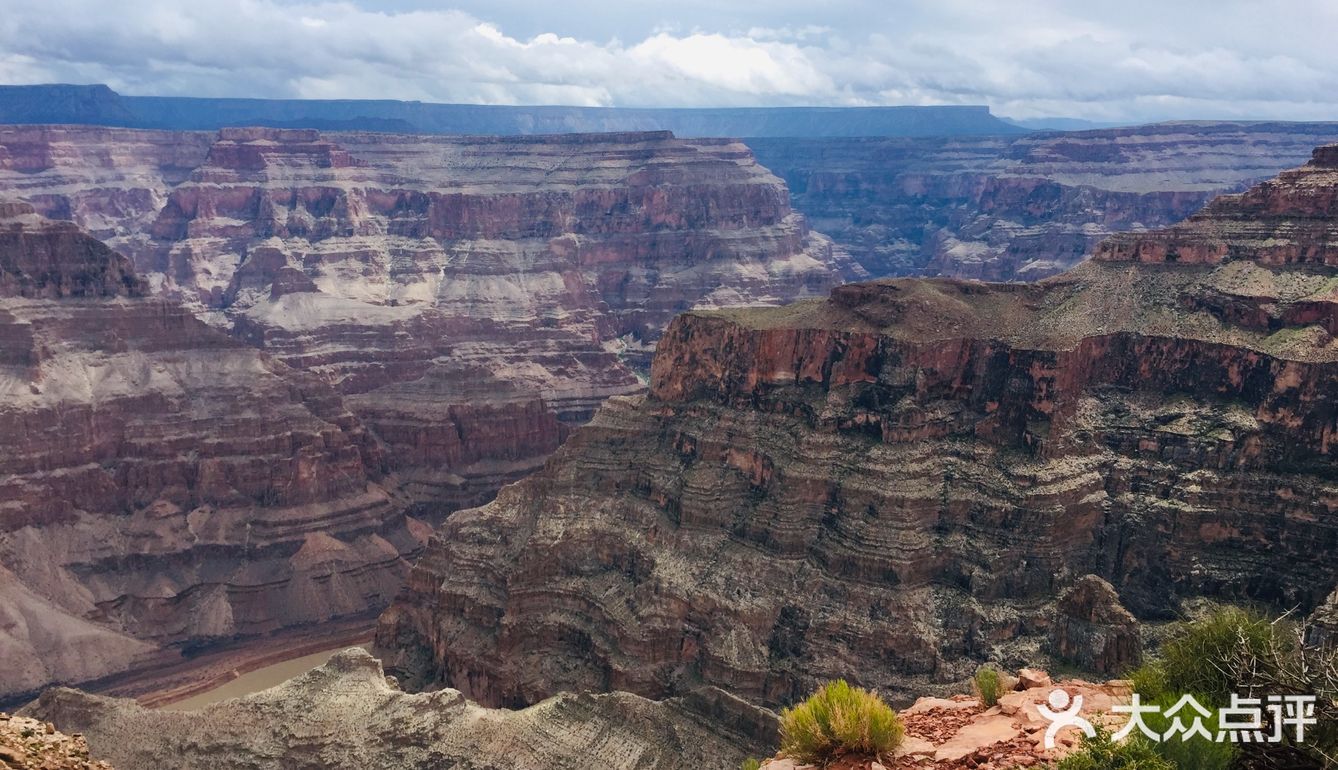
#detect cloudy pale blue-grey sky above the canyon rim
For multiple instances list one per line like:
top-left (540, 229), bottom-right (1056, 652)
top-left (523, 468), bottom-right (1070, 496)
top-left (0, 0), bottom-right (1338, 122)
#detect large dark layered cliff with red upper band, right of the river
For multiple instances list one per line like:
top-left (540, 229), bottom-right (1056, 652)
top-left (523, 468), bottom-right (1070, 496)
top-left (377, 150), bottom-right (1338, 703)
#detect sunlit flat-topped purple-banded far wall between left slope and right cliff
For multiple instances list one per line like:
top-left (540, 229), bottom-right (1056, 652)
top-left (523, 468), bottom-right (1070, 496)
top-left (0, 126), bottom-right (860, 516)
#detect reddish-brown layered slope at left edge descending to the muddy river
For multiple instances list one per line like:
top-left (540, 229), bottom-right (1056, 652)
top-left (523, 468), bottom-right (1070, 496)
top-left (0, 212), bottom-right (427, 698)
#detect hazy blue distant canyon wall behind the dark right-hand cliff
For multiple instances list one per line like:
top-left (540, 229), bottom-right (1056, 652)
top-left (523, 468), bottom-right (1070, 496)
top-left (749, 123), bottom-right (1338, 281)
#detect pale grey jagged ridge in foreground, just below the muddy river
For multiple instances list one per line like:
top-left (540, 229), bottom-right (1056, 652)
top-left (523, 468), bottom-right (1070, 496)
top-left (20, 648), bottom-right (777, 770)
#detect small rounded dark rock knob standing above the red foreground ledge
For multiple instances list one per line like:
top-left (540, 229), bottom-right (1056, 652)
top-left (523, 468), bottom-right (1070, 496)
top-left (1048, 574), bottom-right (1143, 674)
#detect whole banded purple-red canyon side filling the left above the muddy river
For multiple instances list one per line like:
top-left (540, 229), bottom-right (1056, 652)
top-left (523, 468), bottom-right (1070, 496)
top-left (0, 127), bottom-right (858, 699)
